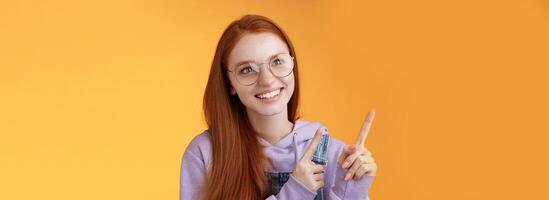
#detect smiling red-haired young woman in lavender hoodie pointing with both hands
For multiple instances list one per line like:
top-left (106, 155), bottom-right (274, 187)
top-left (180, 15), bottom-right (377, 200)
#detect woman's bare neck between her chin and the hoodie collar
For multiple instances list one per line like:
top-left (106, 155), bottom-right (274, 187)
top-left (247, 109), bottom-right (294, 144)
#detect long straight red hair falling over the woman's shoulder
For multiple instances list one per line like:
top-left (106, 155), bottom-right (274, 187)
top-left (203, 15), bottom-right (299, 200)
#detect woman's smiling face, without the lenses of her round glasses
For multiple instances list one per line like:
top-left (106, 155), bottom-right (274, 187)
top-left (227, 33), bottom-right (294, 116)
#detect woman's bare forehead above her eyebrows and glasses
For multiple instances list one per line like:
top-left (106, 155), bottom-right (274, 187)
top-left (228, 33), bottom-right (289, 65)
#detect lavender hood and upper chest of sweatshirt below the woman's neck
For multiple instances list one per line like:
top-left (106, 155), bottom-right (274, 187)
top-left (258, 120), bottom-right (328, 172)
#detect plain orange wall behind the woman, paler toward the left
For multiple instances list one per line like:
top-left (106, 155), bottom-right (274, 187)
top-left (0, 0), bottom-right (549, 200)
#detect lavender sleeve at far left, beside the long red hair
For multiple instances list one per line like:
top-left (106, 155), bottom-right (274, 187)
top-left (179, 151), bottom-right (206, 200)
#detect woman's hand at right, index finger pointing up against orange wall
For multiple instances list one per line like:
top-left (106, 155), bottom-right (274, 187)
top-left (338, 109), bottom-right (377, 180)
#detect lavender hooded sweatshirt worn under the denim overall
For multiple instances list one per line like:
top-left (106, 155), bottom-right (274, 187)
top-left (179, 120), bottom-right (374, 200)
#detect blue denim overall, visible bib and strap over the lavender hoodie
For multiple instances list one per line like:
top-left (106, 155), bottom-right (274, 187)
top-left (265, 134), bottom-right (330, 200)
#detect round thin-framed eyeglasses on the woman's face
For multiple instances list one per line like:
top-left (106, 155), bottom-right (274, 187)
top-left (227, 53), bottom-right (294, 85)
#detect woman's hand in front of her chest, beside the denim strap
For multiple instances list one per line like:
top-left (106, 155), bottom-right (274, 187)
top-left (292, 128), bottom-right (324, 192)
